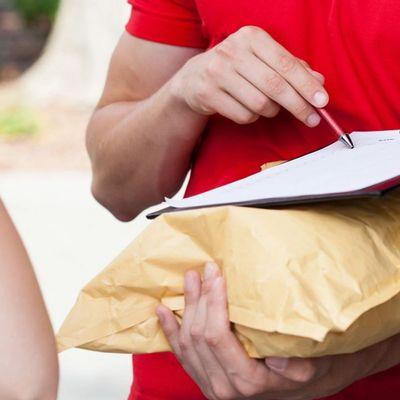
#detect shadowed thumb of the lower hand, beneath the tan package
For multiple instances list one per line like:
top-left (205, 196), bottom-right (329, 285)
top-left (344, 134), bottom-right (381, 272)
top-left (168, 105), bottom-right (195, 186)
top-left (265, 357), bottom-right (317, 383)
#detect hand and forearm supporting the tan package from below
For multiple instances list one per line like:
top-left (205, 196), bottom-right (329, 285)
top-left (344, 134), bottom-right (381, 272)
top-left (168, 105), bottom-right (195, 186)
top-left (157, 264), bottom-right (400, 400)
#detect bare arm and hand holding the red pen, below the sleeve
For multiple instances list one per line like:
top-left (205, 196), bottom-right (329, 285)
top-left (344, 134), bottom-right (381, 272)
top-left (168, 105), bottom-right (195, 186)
top-left (87, 26), bottom-right (328, 221)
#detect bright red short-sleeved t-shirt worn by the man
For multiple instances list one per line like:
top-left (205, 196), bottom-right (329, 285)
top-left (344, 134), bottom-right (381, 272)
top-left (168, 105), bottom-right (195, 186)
top-left (127, 0), bottom-right (400, 400)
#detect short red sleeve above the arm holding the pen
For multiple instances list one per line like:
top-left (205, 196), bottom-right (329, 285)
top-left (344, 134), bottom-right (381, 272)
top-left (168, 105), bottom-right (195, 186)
top-left (126, 0), bottom-right (208, 48)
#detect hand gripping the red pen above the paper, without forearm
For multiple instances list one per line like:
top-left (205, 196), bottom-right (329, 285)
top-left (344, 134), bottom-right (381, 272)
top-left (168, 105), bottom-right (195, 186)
top-left (171, 26), bottom-right (329, 127)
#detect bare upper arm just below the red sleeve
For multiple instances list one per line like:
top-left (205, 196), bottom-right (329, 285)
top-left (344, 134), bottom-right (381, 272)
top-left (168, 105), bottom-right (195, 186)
top-left (98, 33), bottom-right (204, 108)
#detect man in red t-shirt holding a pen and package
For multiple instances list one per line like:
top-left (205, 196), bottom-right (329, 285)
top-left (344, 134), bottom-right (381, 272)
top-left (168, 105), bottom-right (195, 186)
top-left (87, 0), bottom-right (400, 400)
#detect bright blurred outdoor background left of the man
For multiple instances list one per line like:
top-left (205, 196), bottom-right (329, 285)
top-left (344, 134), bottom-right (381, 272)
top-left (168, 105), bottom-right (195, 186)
top-left (0, 0), bottom-right (153, 400)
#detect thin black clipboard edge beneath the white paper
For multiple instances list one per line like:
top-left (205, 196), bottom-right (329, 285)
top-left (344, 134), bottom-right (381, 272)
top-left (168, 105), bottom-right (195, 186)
top-left (146, 176), bottom-right (400, 219)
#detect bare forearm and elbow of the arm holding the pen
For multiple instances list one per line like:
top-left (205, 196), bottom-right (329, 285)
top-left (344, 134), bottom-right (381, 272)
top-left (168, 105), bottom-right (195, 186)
top-left (87, 82), bottom-right (207, 220)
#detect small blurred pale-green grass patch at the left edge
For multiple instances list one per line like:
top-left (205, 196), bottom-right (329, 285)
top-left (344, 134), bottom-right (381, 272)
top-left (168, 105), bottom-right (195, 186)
top-left (0, 108), bottom-right (39, 139)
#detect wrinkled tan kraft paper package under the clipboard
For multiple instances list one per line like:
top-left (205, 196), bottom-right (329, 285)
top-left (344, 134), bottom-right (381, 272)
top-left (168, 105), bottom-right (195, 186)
top-left (57, 191), bottom-right (400, 357)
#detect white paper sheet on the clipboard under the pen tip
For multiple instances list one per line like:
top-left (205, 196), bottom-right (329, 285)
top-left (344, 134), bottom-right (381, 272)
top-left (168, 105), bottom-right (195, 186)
top-left (166, 130), bottom-right (400, 208)
